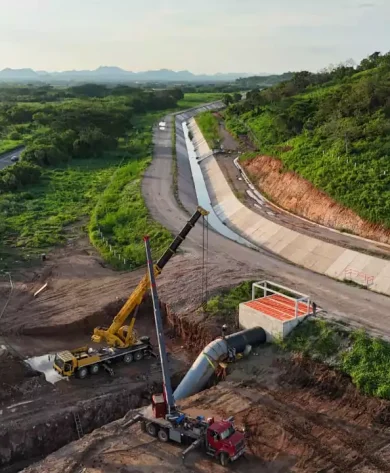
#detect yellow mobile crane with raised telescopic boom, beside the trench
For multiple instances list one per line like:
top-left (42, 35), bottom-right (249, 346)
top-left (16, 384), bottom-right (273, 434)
top-left (53, 207), bottom-right (209, 378)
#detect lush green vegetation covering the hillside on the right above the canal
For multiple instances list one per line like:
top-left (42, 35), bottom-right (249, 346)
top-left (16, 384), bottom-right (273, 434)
top-left (226, 53), bottom-right (390, 227)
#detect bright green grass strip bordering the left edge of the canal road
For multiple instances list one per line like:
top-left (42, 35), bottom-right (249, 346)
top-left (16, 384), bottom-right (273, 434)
top-left (89, 109), bottom-right (171, 269)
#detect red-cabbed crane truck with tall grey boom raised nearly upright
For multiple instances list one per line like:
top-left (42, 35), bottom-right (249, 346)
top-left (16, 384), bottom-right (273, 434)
top-left (126, 237), bottom-right (245, 466)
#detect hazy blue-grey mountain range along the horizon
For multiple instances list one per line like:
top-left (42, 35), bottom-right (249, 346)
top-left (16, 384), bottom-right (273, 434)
top-left (0, 66), bottom-right (258, 83)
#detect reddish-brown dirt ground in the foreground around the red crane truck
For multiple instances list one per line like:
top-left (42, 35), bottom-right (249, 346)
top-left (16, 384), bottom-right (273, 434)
top-left (25, 346), bottom-right (390, 473)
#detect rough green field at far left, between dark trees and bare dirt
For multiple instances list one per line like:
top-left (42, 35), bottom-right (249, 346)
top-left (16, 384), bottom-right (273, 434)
top-left (0, 158), bottom-right (120, 269)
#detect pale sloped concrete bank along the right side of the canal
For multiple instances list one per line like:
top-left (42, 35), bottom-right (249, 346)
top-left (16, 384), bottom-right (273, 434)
top-left (189, 119), bottom-right (390, 295)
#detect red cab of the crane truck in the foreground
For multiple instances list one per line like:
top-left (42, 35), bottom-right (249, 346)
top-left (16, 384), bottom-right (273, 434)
top-left (206, 420), bottom-right (245, 466)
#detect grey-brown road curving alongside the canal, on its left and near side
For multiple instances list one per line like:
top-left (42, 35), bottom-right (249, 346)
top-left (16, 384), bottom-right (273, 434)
top-left (142, 106), bottom-right (390, 339)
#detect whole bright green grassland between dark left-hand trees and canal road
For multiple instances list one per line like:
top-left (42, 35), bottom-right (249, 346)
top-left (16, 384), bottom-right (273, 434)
top-left (0, 94), bottom-right (219, 270)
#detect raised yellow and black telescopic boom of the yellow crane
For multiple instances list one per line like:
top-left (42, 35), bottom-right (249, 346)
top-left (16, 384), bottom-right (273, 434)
top-left (92, 206), bottom-right (209, 348)
